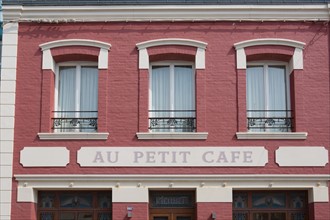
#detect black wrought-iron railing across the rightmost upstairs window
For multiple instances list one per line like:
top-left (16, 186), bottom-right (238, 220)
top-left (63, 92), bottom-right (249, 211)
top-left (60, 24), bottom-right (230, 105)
top-left (247, 110), bottom-right (293, 132)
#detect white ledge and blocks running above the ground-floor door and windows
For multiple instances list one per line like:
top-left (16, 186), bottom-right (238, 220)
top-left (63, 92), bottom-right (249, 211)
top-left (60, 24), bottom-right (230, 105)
top-left (15, 174), bottom-right (330, 203)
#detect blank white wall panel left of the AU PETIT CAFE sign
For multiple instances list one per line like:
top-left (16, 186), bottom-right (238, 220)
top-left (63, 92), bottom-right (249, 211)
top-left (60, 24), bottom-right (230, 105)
top-left (20, 147), bottom-right (70, 167)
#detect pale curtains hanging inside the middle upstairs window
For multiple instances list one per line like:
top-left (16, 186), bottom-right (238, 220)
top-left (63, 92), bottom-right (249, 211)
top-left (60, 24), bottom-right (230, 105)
top-left (149, 65), bottom-right (195, 131)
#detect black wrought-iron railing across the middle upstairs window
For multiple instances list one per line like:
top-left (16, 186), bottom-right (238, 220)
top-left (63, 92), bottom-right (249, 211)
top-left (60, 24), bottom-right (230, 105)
top-left (149, 110), bottom-right (196, 132)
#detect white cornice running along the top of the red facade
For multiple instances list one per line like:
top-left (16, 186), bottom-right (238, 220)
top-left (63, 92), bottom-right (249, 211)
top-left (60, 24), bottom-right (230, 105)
top-left (2, 4), bottom-right (330, 22)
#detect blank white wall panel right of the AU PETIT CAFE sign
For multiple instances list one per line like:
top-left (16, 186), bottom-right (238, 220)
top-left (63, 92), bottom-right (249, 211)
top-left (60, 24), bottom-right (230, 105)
top-left (275, 146), bottom-right (329, 167)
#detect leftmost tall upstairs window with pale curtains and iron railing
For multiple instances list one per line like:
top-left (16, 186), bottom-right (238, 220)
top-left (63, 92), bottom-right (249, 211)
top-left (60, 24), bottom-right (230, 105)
top-left (53, 64), bottom-right (98, 132)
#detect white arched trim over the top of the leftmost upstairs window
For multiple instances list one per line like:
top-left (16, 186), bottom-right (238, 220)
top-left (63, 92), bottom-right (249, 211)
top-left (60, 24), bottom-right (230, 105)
top-left (39, 39), bottom-right (111, 69)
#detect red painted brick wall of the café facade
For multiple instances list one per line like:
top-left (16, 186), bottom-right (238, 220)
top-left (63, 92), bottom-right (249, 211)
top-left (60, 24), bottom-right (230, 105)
top-left (13, 22), bottom-right (330, 219)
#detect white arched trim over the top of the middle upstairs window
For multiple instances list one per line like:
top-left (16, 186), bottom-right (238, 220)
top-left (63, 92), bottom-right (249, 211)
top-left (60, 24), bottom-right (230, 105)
top-left (136, 38), bottom-right (207, 69)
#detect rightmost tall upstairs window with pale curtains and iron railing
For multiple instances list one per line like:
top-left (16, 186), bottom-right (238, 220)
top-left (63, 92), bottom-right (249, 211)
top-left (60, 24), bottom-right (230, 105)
top-left (246, 63), bottom-right (292, 132)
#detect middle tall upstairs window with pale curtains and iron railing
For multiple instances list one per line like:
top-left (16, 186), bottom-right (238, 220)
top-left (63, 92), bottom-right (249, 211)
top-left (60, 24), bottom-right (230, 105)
top-left (149, 63), bottom-right (196, 132)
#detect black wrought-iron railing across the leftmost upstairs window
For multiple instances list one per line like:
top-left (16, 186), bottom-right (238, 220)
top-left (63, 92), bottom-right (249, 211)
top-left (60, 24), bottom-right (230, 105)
top-left (52, 111), bottom-right (98, 132)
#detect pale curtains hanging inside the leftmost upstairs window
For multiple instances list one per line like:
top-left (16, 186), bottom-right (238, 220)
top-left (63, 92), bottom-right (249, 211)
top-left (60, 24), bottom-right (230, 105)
top-left (57, 66), bottom-right (98, 132)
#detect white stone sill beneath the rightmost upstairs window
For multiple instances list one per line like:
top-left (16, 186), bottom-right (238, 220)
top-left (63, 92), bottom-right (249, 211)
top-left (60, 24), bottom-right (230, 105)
top-left (236, 132), bottom-right (308, 140)
